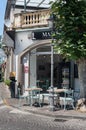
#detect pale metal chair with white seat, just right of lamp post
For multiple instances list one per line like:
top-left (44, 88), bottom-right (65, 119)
top-left (60, 90), bottom-right (74, 110)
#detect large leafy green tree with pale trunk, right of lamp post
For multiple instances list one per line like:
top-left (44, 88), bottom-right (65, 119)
top-left (51, 0), bottom-right (86, 110)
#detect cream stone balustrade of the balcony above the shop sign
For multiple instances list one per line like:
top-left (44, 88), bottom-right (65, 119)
top-left (13, 10), bottom-right (50, 28)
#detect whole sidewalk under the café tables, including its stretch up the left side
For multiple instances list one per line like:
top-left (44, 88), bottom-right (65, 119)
top-left (0, 83), bottom-right (86, 126)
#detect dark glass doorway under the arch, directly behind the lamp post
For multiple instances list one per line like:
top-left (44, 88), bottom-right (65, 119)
top-left (36, 46), bottom-right (60, 91)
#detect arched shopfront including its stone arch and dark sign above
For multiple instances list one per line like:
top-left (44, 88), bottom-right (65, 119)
top-left (17, 31), bottom-right (78, 91)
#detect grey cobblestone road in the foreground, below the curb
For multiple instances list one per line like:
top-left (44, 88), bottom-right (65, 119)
top-left (0, 106), bottom-right (86, 130)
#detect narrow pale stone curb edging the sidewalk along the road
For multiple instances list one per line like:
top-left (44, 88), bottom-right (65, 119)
top-left (2, 95), bottom-right (86, 120)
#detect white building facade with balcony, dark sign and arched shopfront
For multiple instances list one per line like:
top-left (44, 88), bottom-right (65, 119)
top-left (4, 0), bottom-right (79, 95)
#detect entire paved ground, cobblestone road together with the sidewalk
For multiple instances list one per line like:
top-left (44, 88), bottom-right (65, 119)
top-left (0, 84), bottom-right (86, 130)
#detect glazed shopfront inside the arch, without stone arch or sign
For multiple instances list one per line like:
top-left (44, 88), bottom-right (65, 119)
top-left (24, 45), bottom-right (77, 91)
